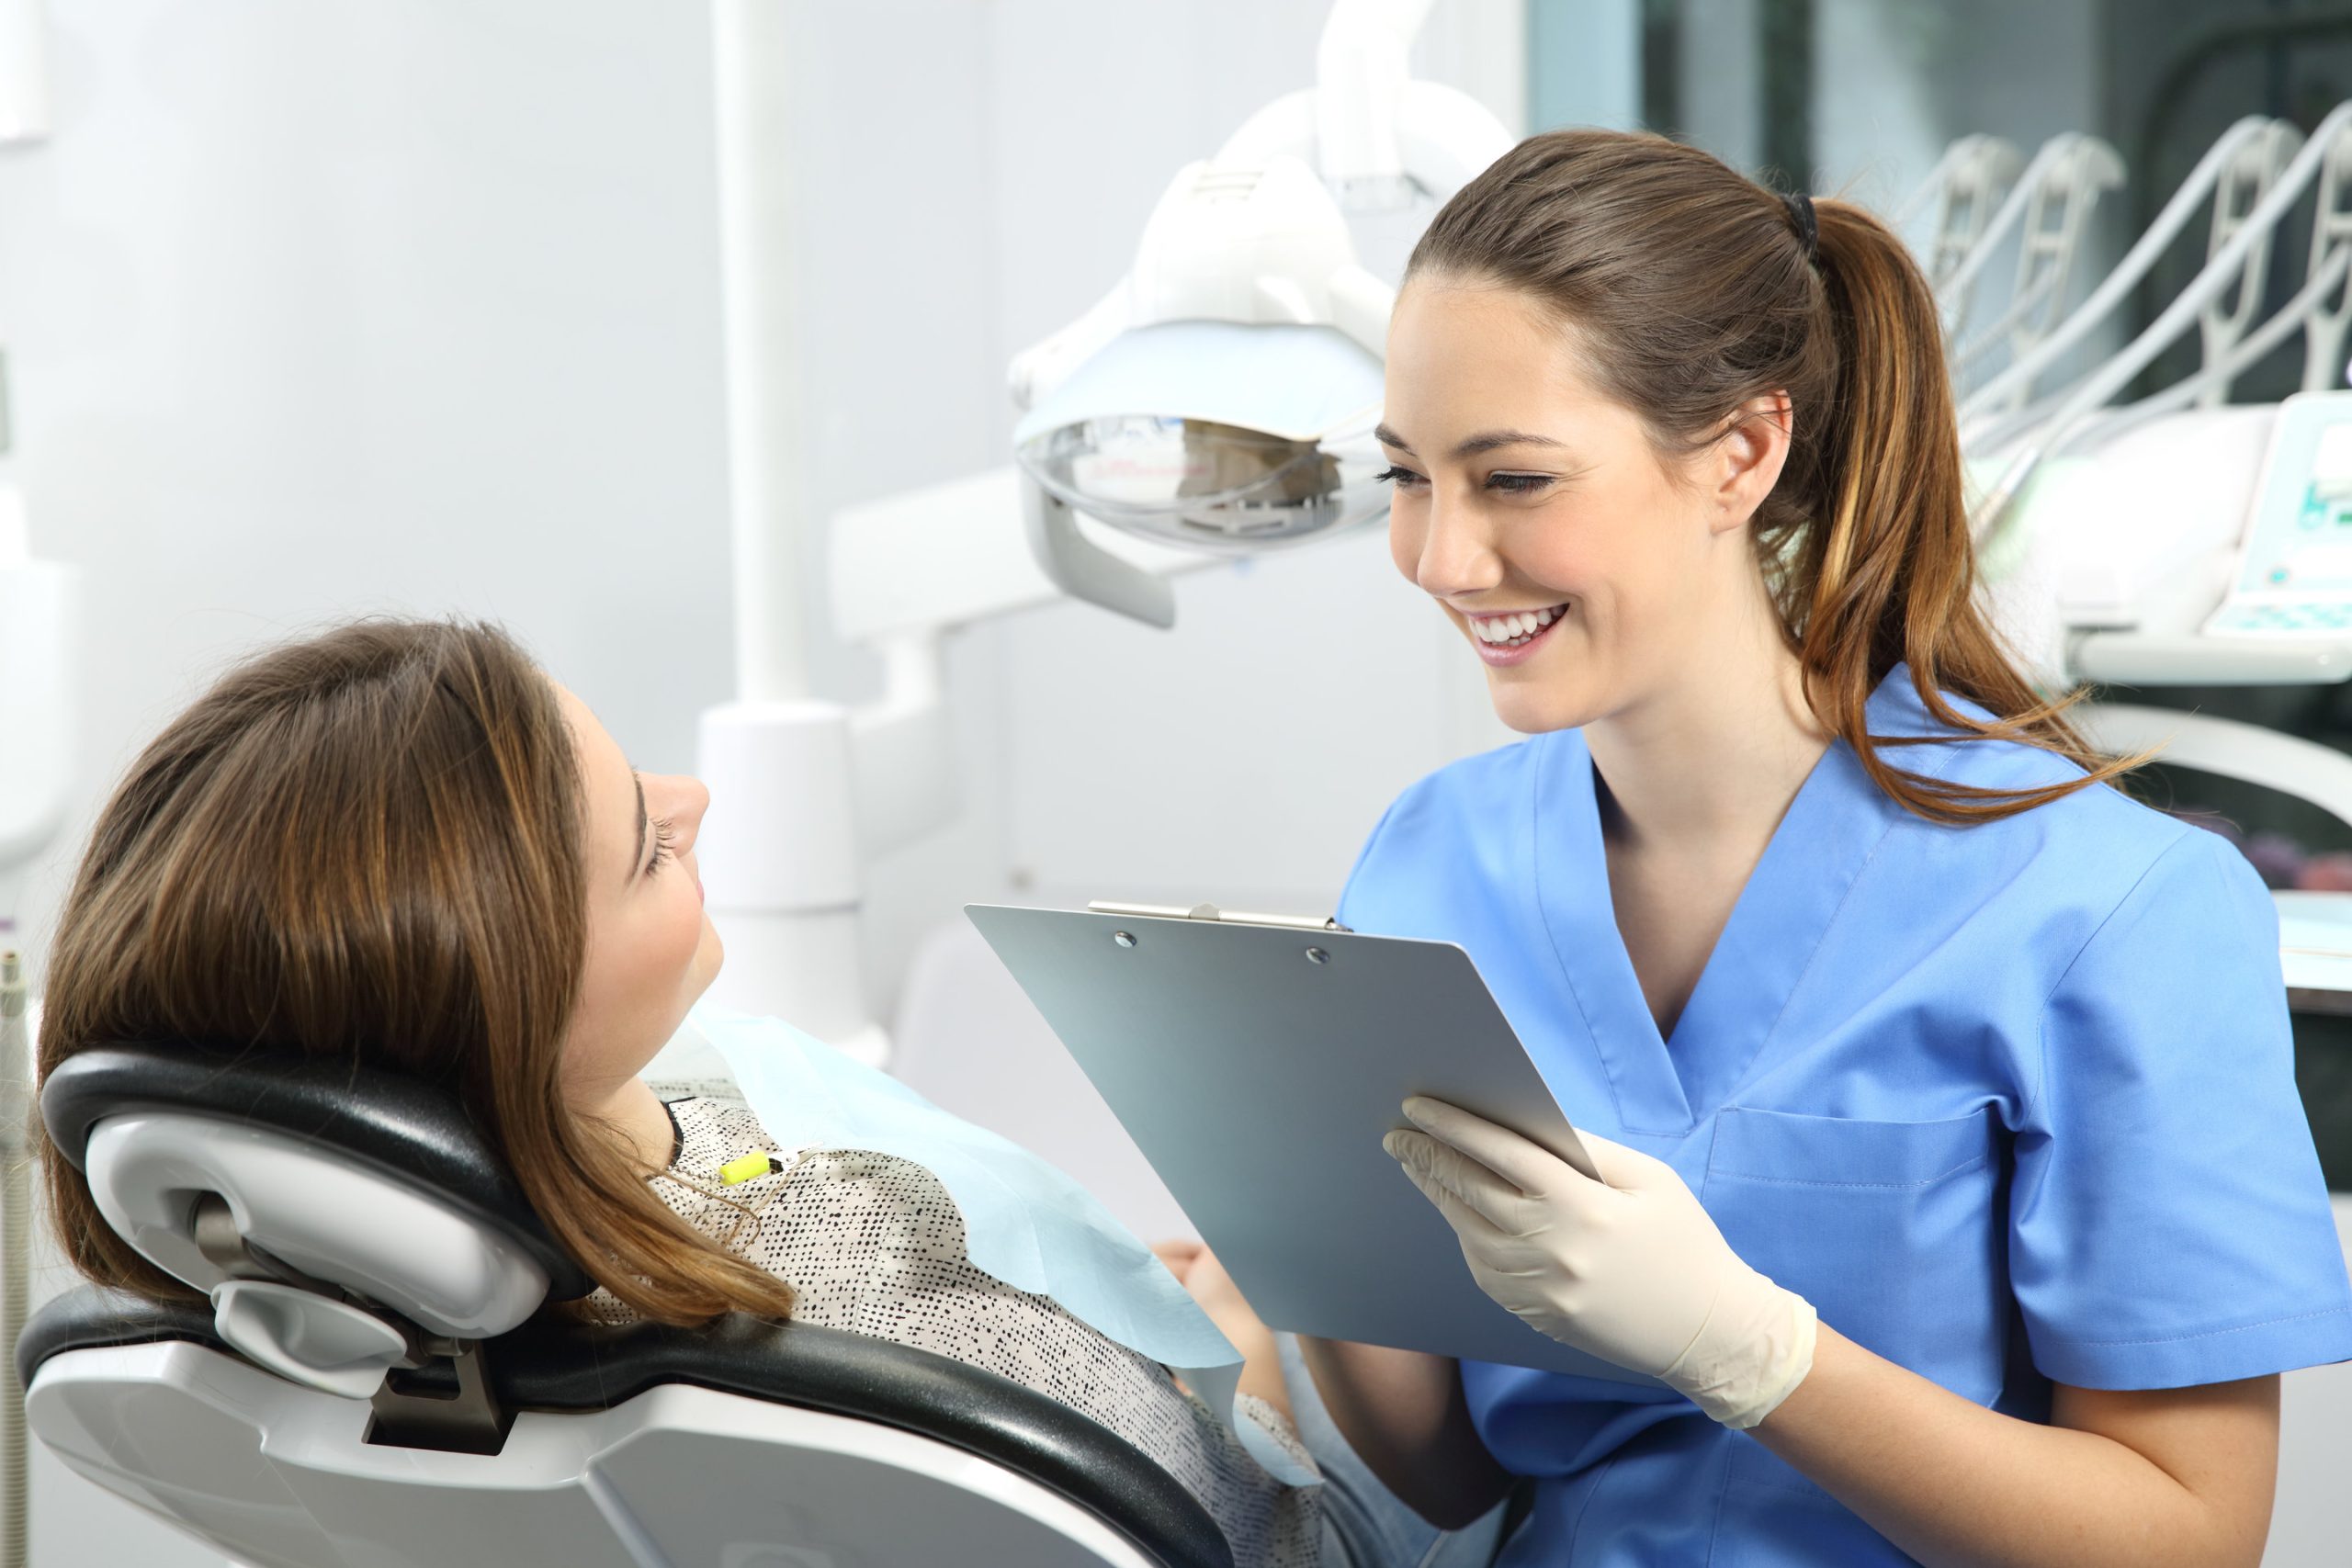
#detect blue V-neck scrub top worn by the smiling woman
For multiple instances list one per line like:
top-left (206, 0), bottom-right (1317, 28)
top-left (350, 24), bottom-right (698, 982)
top-left (1340, 665), bottom-right (2352, 1568)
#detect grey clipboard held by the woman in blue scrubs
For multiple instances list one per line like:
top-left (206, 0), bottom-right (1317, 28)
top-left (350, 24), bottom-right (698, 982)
top-left (965, 903), bottom-right (1663, 1389)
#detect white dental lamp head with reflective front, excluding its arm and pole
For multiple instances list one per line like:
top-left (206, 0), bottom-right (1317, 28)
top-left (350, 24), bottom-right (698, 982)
top-left (1013, 152), bottom-right (1395, 627)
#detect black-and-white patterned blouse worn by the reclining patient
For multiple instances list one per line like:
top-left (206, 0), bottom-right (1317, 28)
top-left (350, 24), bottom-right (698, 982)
top-left (583, 1096), bottom-right (1322, 1568)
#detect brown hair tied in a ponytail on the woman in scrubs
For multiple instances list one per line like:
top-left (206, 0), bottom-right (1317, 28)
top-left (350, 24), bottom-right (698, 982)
top-left (1407, 130), bottom-right (2141, 823)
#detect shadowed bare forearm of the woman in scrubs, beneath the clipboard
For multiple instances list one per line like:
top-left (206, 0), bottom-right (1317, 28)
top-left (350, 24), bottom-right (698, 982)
top-left (1298, 1336), bottom-right (1512, 1530)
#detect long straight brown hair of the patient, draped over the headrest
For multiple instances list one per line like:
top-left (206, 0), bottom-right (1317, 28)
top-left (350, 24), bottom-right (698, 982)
top-left (40, 621), bottom-right (793, 1324)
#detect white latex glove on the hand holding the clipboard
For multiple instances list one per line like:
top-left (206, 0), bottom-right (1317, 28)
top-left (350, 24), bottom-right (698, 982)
top-left (1381, 1096), bottom-right (1815, 1429)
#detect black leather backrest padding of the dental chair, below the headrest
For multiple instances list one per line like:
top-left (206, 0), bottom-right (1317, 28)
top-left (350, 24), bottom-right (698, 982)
top-left (17, 1286), bottom-right (1232, 1568)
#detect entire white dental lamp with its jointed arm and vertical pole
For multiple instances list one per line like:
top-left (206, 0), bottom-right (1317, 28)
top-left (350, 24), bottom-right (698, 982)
top-left (686, 0), bottom-right (1512, 1075)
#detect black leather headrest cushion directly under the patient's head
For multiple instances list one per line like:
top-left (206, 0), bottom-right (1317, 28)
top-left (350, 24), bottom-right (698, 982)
top-left (40, 1043), bottom-right (595, 1300)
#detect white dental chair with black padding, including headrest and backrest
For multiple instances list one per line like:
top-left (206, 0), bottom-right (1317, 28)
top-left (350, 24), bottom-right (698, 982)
top-left (17, 1046), bottom-right (1232, 1568)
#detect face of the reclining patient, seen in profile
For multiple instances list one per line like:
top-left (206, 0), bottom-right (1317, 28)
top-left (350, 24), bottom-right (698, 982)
top-left (558, 686), bottom-right (722, 1105)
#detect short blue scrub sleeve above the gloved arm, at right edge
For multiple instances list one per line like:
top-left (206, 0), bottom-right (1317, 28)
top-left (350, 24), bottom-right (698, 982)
top-left (2008, 829), bottom-right (2352, 1389)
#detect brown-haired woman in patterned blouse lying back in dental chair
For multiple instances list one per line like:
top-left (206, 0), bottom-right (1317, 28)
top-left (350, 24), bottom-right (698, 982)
top-left (40, 621), bottom-right (1486, 1565)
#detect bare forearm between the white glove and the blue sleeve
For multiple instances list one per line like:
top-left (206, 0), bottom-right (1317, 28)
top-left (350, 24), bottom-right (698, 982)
top-left (1752, 1324), bottom-right (2277, 1568)
